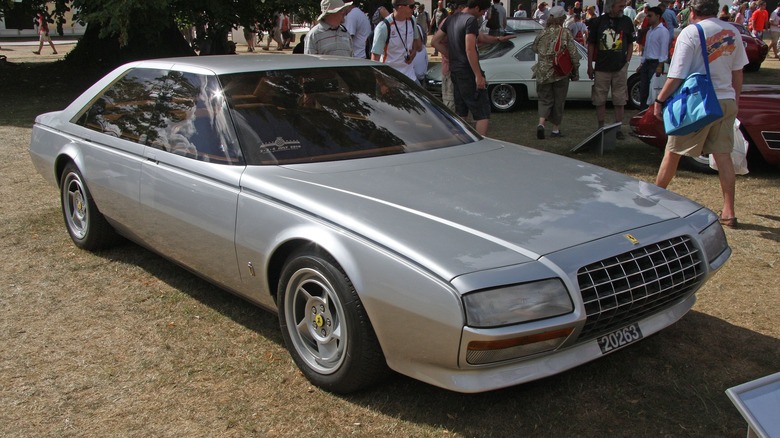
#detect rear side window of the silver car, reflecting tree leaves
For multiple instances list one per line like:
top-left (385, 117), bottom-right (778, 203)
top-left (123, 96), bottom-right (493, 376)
top-left (76, 69), bottom-right (166, 144)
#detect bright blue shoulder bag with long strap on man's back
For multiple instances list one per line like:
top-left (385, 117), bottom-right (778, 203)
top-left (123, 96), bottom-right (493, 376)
top-left (664, 24), bottom-right (723, 135)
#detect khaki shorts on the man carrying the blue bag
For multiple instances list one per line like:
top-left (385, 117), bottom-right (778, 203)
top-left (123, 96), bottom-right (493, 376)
top-left (666, 99), bottom-right (737, 157)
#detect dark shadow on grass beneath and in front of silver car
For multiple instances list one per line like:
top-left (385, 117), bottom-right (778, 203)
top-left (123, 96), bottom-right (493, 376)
top-left (93, 238), bottom-right (780, 437)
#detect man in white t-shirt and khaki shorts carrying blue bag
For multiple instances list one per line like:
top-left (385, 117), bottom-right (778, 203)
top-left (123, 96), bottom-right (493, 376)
top-left (653, 0), bottom-right (748, 228)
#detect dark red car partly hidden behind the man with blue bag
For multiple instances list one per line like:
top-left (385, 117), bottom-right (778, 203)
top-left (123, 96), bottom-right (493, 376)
top-left (630, 85), bottom-right (780, 170)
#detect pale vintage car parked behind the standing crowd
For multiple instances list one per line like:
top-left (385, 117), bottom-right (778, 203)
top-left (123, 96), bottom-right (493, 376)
top-left (426, 32), bottom-right (639, 112)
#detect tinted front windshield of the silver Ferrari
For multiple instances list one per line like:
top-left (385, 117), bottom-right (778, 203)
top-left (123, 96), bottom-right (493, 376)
top-left (220, 66), bottom-right (478, 164)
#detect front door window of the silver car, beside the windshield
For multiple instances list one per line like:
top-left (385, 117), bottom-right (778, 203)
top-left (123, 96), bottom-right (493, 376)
top-left (148, 71), bottom-right (243, 164)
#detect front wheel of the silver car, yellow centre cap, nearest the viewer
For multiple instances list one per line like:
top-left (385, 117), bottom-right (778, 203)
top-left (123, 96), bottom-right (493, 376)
top-left (277, 249), bottom-right (388, 394)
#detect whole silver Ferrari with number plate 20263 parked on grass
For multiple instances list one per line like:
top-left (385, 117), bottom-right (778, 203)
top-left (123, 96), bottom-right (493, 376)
top-left (30, 55), bottom-right (731, 392)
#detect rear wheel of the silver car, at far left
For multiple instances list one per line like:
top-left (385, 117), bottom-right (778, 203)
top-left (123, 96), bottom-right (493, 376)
top-left (60, 162), bottom-right (117, 251)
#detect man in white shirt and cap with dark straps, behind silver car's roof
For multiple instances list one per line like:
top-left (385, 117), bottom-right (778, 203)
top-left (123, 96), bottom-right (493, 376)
top-left (371, 0), bottom-right (422, 81)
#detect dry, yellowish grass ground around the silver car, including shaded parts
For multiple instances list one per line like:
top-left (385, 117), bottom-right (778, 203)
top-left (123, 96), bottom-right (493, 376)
top-left (0, 45), bottom-right (780, 437)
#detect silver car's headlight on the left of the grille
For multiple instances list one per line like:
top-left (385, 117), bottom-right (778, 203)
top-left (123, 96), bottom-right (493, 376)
top-left (463, 278), bottom-right (574, 327)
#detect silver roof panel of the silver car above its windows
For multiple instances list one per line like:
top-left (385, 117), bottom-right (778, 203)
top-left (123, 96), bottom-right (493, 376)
top-left (124, 54), bottom-right (379, 75)
